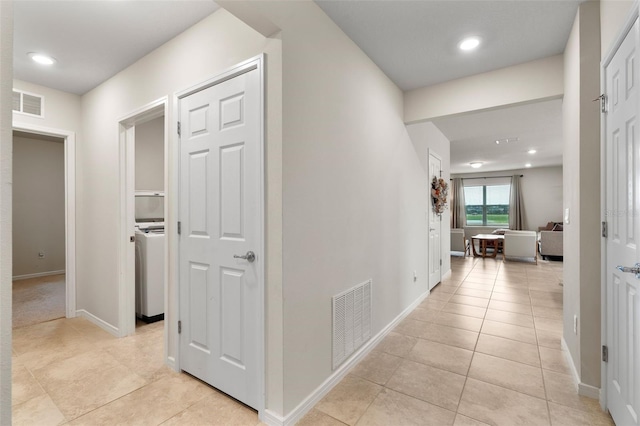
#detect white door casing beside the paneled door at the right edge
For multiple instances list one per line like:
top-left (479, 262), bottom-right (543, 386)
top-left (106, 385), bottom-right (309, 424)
top-left (600, 0), bottom-right (640, 411)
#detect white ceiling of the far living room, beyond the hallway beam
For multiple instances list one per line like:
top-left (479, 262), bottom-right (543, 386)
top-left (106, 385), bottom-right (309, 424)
top-left (433, 99), bottom-right (562, 174)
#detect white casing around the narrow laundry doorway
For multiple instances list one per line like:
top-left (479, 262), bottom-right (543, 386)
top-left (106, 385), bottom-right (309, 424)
top-left (118, 96), bottom-right (170, 342)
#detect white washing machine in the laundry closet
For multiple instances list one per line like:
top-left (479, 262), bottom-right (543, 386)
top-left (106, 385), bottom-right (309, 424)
top-left (135, 223), bottom-right (164, 322)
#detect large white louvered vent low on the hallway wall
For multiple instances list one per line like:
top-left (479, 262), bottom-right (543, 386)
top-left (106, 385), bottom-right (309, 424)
top-left (332, 280), bottom-right (371, 370)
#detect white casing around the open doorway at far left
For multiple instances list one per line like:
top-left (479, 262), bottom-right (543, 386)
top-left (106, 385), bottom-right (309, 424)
top-left (13, 120), bottom-right (76, 318)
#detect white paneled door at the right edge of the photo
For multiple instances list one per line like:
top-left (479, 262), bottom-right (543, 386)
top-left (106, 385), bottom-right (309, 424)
top-left (605, 16), bottom-right (640, 426)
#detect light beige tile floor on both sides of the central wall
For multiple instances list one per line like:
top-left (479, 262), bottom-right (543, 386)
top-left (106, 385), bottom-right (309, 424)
top-left (13, 257), bottom-right (613, 426)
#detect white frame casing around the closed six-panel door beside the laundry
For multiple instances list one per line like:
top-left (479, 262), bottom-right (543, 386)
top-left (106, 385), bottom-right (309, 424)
top-left (171, 54), bottom-right (268, 421)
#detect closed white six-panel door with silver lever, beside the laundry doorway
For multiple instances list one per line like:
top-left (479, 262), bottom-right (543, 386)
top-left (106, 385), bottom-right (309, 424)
top-left (179, 64), bottom-right (263, 409)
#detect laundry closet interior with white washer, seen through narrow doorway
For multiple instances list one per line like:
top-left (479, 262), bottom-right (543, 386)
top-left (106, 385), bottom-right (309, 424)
top-left (135, 117), bottom-right (165, 323)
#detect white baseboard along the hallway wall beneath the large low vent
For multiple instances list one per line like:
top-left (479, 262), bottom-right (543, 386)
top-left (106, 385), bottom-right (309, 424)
top-left (272, 290), bottom-right (429, 426)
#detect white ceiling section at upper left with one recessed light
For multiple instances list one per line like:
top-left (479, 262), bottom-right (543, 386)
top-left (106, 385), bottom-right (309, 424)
top-left (13, 0), bottom-right (218, 94)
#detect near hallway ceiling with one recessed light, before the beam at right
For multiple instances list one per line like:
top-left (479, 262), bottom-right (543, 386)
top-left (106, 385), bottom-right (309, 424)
top-left (315, 0), bottom-right (584, 90)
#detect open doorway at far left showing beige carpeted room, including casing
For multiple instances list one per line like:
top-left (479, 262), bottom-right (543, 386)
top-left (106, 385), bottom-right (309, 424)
top-left (12, 124), bottom-right (76, 328)
